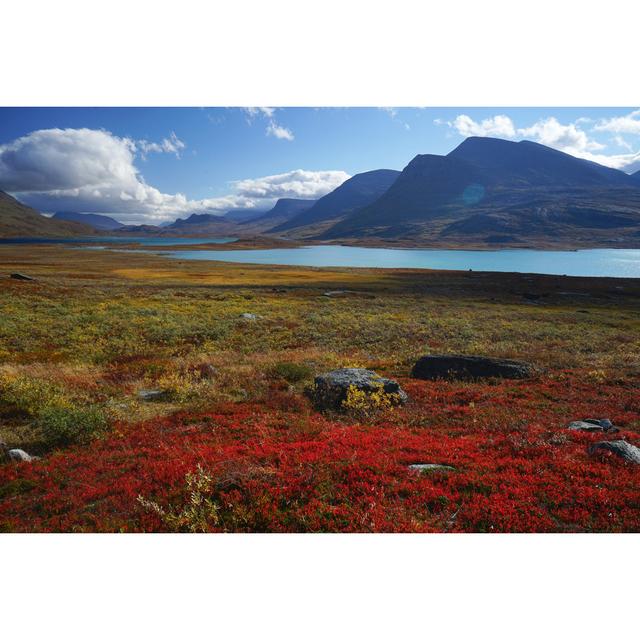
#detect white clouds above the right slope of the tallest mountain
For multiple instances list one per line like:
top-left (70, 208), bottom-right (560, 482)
top-left (434, 111), bottom-right (640, 173)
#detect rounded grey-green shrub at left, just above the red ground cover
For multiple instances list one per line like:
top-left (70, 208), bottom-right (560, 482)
top-left (36, 406), bottom-right (108, 446)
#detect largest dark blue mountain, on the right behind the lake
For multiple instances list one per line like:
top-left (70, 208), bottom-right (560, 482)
top-left (318, 137), bottom-right (640, 244)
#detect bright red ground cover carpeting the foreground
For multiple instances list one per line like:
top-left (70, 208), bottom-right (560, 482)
top-left (0, 373), bottom-right (640, 532)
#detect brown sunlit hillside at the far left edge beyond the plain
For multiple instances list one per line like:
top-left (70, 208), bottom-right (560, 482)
top-left (0, 191), bottom-right (95, 238)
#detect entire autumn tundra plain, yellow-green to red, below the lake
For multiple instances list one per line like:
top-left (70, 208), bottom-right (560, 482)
top-left (0, 246), bottom-right (640, 532)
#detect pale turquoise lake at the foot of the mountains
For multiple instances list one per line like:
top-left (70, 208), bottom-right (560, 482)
top-left (152, 245), bottom-right (640, 278)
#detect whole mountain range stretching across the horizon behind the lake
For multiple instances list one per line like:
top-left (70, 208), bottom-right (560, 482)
top-left (0, 137), bottom-right (640, 246)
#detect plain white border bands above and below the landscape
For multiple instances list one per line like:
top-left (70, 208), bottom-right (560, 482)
top-left (0, 0), bottom-right (640, 640)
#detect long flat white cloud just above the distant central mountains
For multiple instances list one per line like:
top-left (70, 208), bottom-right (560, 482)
top-left (234, 169), bottom-right (351, 199)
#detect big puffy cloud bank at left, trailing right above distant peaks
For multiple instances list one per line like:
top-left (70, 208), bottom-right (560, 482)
top-left (0, 129), bottom-right (349, 224)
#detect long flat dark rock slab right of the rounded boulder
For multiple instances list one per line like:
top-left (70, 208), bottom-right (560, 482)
top-left (411, 355), bottom-right (539, 380)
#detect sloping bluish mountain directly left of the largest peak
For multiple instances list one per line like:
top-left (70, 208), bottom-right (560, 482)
top-left (271, 169), bottom-right (400, 238)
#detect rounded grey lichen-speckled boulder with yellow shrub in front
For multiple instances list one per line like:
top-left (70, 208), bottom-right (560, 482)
top-left (307, 369), bottom-right (408, 411)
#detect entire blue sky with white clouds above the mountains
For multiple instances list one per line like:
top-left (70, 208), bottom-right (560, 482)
top-left (0, 107), bottom-right (640, 224)
